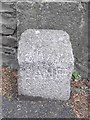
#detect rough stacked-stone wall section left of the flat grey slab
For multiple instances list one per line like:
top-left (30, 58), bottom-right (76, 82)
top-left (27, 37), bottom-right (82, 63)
top-left (0, 3), bottom-right (18, 69)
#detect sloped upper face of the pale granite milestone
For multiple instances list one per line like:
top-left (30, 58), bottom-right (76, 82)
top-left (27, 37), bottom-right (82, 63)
top-left (18, 29), bottom-right (74, 64)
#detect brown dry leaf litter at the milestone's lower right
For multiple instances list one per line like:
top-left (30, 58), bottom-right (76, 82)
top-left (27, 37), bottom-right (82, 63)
top-left (70, 80), bottom-right (90, 118)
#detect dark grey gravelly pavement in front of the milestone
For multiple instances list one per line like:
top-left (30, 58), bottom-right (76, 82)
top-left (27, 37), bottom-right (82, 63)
top-left (2, 98), bottom-right (75, 118)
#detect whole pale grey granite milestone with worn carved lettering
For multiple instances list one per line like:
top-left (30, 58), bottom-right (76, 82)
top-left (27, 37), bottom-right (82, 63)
top-left (18, 29), bottom-right (74, 100)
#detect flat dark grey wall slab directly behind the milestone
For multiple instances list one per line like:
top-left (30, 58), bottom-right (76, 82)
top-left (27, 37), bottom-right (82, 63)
top-left (17, 2), bottom-right (89, 78)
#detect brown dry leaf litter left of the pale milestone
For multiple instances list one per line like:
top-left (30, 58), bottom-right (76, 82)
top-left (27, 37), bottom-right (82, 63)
top-left (2, 68), bottom-right (17, 98)
